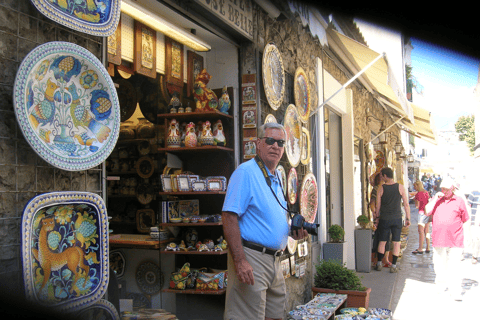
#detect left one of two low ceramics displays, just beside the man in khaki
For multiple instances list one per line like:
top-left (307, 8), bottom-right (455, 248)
top-left (288, 293), bottom-right (347, 320)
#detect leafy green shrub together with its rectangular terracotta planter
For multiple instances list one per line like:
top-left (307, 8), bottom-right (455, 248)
top-left (312, 260), bottom-right (372, 308)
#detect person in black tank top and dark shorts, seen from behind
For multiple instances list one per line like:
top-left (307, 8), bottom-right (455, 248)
top-left (374, 167), bottom-right (410, 273)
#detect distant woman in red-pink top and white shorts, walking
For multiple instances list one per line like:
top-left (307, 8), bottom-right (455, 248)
top-left (412, 180), bottom-right (431, 254)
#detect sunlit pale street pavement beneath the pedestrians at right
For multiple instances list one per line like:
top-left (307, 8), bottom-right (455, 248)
top-left (390, 205), bottom-right (480, 320)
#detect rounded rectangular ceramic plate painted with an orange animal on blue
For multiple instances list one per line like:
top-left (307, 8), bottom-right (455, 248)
top-left (22, 191), bottom-right (109, 311)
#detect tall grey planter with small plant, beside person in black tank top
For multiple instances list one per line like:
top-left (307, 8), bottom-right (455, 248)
top-left (355, 214), bottom-right (372, 272)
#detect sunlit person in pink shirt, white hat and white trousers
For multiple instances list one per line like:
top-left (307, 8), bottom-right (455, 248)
top-left (425, 177), bottom-right (469, 301)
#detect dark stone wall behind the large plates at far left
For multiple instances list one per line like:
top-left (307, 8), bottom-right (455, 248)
top-left (0, 0), bottom-right (103, 292)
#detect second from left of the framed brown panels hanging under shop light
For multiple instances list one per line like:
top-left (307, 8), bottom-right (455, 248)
top-left (134, 21), bottom-right (157, 79)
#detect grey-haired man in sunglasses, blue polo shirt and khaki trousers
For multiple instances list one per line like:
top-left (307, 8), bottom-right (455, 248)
top-left (222, 123), bottom-right (308, 320)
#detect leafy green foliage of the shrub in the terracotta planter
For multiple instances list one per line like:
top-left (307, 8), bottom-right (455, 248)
top-left (314, 260), bottom-right (366, 291)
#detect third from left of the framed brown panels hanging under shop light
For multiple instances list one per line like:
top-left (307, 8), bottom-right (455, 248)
top-left (165, 36), bottom-right (184, 88)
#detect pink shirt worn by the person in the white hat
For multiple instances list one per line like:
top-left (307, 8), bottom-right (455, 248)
top-left (432, 195), bottom-right (470, 248)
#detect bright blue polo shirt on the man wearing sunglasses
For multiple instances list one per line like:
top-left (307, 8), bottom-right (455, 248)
top-left (222, 159), bottom-right (290, 250)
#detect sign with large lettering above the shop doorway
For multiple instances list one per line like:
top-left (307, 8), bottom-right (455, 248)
top-left (195, 0), bottom-right (253, 40)
